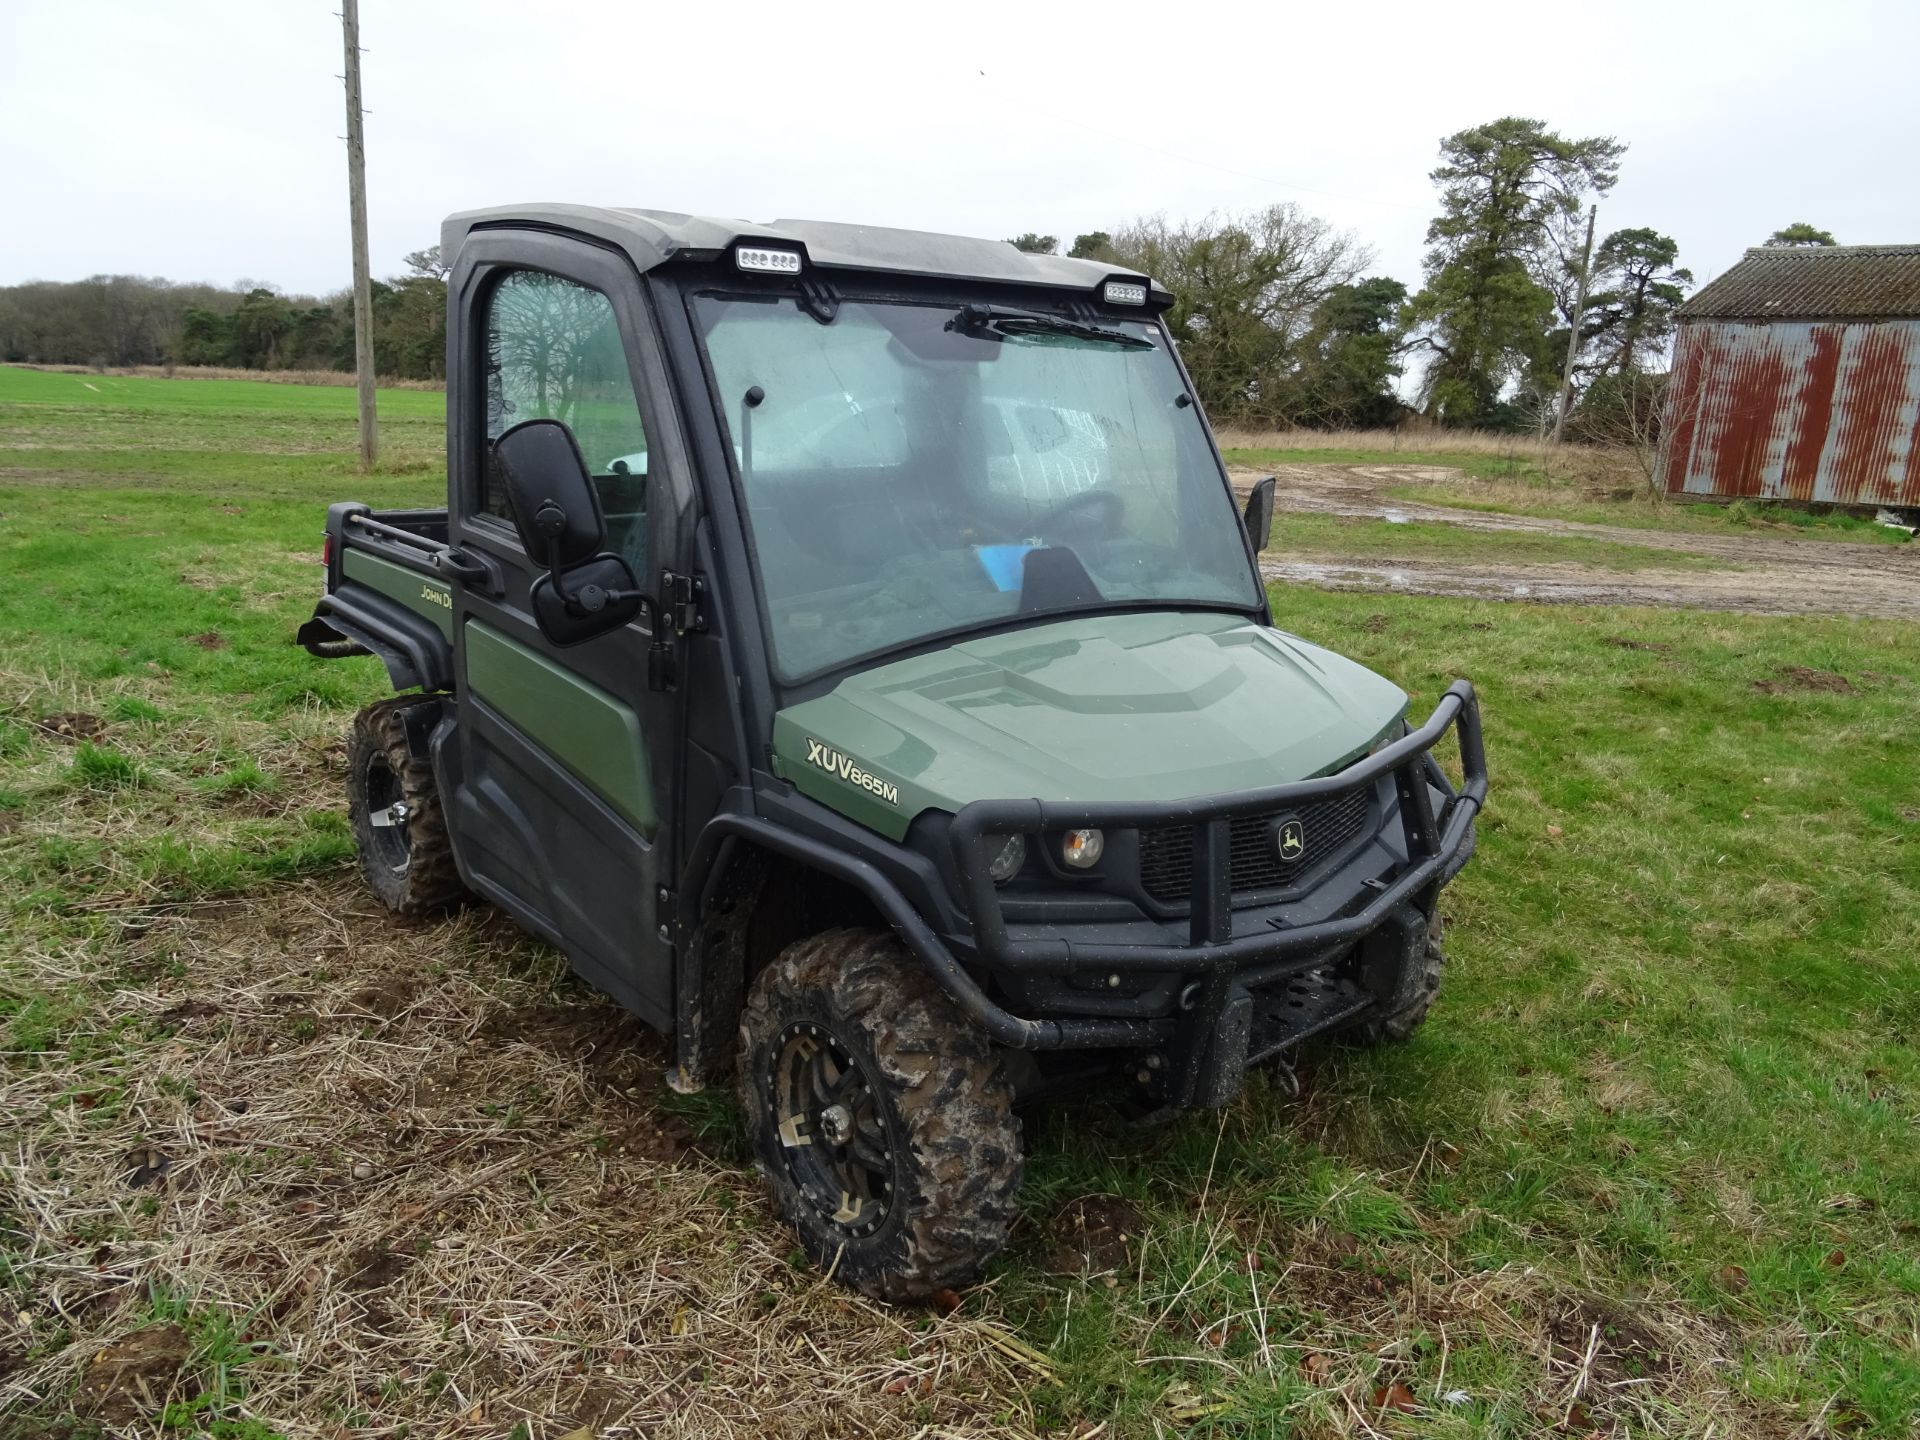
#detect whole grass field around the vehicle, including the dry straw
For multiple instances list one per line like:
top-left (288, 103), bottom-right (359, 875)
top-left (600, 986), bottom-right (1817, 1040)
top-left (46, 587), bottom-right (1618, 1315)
top-left (0, 369), bottom-right (1920, 1440)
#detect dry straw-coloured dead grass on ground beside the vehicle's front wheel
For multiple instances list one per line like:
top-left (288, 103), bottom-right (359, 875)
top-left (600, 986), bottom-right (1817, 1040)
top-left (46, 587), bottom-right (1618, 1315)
top-left (0, 877), bottom-right (1751, 1440)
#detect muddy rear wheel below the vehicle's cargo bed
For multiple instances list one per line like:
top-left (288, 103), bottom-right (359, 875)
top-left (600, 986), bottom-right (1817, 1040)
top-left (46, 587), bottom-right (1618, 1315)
top-left (348, 697), bottom-right (472, 916)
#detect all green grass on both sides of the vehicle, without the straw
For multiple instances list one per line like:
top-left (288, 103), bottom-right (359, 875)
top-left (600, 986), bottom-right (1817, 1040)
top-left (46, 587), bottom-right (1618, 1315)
top-left (11, 371), bottom-right (1920, 1440)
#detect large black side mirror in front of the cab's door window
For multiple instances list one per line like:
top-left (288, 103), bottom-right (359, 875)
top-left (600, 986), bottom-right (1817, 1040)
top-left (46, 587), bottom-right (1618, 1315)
top-left (493, 420), bottom-right (651, 645)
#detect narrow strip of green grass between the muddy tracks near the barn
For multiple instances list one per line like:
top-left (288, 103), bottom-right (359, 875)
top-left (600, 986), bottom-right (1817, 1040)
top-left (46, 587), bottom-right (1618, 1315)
top-left (1269, 511), bottom-right (1741, 572)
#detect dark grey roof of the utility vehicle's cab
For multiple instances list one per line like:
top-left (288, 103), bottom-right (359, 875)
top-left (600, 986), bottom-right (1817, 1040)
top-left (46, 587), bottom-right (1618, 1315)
top-left (440, 205), bottom-right (1173, 305)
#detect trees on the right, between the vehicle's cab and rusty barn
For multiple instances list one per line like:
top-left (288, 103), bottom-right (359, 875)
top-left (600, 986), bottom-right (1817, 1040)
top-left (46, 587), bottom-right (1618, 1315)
top-left (1010, 117), bottom-right (1836, 438)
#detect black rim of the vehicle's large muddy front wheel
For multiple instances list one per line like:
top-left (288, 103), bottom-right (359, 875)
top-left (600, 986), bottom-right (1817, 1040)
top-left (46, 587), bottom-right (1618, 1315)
top-left (766, 1021), bottom-right (897, 1238)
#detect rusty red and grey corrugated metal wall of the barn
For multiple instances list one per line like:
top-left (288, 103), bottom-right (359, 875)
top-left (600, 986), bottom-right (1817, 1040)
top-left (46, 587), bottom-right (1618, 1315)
top-left (1661, 319), bottom-right (1920, 505)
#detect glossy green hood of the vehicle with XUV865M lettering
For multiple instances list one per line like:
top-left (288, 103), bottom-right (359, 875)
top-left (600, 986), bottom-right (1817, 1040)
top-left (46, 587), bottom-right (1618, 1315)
top-left (774, 612), bottom-right (1407, 839)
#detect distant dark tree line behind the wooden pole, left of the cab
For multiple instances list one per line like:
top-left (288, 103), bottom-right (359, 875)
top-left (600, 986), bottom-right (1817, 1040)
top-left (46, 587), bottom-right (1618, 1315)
top-left (0, 246), bottom-right (447, 380)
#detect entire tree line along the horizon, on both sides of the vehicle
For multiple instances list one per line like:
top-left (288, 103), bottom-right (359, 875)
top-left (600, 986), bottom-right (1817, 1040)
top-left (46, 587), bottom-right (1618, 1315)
top-left (0, 117), bottom-right (1836, 438)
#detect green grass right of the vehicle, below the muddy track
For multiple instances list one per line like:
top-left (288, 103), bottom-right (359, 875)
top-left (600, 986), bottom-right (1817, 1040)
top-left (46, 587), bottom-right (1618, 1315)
top-left (1008, 588), bottom-right (1920, 1436)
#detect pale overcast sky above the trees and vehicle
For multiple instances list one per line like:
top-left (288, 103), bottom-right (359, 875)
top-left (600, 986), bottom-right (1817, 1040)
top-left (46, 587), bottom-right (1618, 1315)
top-left (0, 0), bottom-right (1920, 292)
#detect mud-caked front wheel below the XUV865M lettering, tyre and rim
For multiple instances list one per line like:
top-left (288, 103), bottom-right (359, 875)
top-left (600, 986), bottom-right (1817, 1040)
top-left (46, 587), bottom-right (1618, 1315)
top-left (739, 929), bottom-right (1021, 1300)
